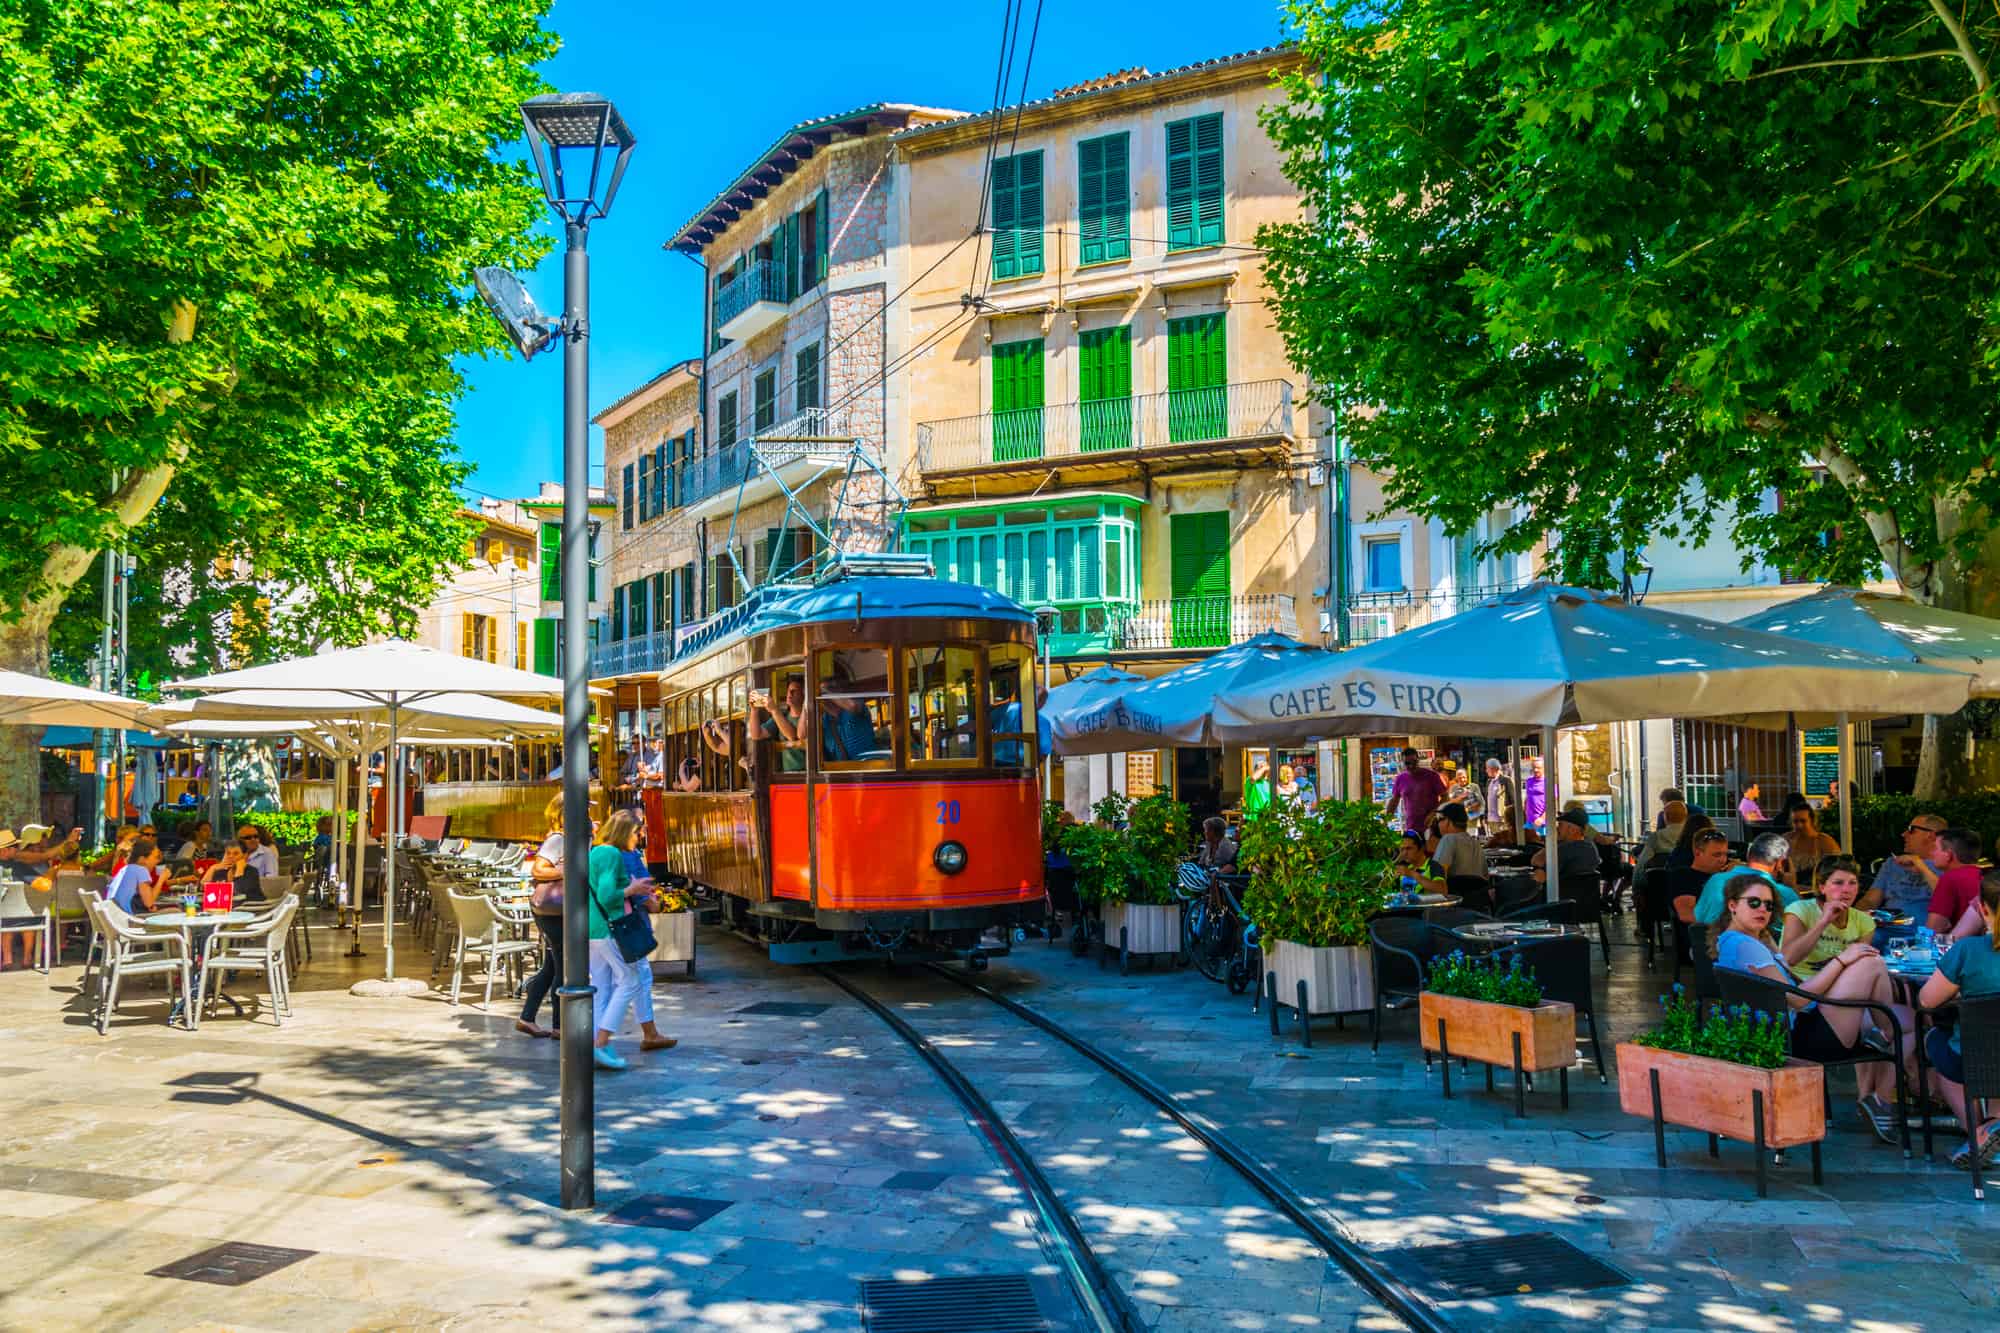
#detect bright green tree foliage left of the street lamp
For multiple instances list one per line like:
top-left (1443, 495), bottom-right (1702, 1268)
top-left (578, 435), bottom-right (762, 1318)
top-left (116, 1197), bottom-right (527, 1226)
top-left (0, 0), bottom-right (554, 795)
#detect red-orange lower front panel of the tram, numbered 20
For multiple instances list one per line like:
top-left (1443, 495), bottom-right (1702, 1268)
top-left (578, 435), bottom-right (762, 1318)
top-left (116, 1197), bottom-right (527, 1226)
top-left (808, 777), bottom-right (1042, 911)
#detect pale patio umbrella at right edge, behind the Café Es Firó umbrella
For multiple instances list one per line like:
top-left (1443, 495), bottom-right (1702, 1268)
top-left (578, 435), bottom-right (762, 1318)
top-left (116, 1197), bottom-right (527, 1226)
top-left (1738, 586), bottom-right (2000, 847)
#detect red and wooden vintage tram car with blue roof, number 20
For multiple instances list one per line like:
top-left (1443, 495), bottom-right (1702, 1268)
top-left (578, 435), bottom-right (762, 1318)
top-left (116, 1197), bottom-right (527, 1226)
top-left (644, 562), bottom-right (1044, 963)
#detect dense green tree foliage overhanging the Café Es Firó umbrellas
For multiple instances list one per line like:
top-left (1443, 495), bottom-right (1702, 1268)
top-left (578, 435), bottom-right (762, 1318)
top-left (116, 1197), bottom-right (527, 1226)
top-left (1260, 0), bottom-right (2000, 604)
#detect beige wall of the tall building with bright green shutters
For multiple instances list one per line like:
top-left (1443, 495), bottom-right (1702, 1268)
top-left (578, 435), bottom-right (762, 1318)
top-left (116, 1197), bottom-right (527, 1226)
top-left (890, 52), bottom-right (1326, 636)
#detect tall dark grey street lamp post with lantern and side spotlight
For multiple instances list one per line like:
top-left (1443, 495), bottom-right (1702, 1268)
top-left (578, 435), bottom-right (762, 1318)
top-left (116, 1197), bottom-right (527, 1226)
top-left (492, 92), bottom-right (636, 1209)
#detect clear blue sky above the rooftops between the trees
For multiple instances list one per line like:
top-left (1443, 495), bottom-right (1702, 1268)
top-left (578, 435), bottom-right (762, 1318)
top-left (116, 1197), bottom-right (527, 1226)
top-left (458, 0), bottom-right (1282, 496)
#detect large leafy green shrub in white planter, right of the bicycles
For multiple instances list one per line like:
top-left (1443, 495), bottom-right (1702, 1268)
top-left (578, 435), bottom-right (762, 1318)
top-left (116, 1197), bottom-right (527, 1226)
top-left (1236, 801), bottom-right (1400, 949)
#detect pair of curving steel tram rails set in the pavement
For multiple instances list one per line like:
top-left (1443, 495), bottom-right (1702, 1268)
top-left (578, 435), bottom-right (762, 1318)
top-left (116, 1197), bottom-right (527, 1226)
top-left (820, 963), bottom-right (1452, 1333)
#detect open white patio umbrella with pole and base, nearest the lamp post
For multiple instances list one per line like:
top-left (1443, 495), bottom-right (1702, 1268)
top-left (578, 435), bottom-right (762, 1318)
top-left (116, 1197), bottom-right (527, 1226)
top-left (166, 642), bottom-right (562, 995)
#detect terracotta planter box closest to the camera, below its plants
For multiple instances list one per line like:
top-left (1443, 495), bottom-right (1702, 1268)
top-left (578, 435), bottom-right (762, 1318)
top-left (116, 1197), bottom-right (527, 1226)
top-left (1618, 1041), bottom-right (1826, 1144)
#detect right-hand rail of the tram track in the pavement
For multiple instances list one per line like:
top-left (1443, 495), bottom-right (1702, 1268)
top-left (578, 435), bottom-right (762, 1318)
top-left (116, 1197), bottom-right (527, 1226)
top-left (926, 963), bottom-right (1454, 1333)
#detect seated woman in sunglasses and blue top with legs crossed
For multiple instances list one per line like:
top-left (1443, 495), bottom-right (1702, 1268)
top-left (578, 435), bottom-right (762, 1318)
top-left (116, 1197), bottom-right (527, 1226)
top-left (1708, 873), bottom-right (1914, 1143)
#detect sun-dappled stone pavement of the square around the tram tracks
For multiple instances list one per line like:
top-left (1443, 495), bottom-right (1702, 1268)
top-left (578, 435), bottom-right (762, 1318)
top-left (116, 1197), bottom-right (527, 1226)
top-left (0, 912), bottom-right (2000, 1333)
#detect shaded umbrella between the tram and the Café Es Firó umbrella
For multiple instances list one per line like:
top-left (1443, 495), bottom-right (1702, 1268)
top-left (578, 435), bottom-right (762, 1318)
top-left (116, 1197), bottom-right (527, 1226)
top-left (1050, 632), bottom-right (1334, 755)
